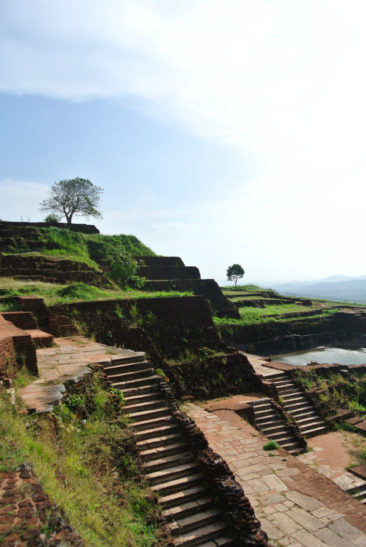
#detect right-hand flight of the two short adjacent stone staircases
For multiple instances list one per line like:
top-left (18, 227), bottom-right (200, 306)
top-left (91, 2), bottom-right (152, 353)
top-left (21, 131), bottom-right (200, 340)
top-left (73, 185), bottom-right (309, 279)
top-left (268, 372), bottom-right (328, 437)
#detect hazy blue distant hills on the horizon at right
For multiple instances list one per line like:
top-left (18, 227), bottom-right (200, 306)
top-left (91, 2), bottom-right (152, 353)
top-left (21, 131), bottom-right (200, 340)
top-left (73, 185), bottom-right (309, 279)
top-left (273, 275), bottom-right (366, 303)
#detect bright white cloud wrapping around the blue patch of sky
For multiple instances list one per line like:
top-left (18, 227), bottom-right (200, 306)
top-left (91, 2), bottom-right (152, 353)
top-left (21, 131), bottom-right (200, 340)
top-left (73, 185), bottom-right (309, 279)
top-left (0, 0), bottom-right (366, 278)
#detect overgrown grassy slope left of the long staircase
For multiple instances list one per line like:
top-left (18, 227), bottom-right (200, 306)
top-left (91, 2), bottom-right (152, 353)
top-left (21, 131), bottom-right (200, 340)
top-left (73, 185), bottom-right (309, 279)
top-left (0, 376), bottom-right (164, 547)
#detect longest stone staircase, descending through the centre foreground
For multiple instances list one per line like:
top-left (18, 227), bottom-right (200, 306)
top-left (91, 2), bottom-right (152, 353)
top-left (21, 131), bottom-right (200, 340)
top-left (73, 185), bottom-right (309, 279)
top-left (104, 352), bottom-right (234, 547)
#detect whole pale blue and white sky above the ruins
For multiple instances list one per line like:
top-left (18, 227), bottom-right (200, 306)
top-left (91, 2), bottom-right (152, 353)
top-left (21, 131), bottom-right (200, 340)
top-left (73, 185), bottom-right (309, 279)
top-left (0, 0), bottom-right (366, 284)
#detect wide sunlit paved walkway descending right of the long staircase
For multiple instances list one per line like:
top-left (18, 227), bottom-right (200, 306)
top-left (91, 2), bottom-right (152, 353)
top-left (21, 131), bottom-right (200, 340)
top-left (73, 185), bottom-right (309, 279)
top-left (184, 404), bottom-right (366, 547)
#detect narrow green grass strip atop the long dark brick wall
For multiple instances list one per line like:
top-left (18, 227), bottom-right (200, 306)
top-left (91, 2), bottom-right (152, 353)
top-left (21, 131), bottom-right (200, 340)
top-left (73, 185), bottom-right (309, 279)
top-left (0, 278), bottom-right (193, 311)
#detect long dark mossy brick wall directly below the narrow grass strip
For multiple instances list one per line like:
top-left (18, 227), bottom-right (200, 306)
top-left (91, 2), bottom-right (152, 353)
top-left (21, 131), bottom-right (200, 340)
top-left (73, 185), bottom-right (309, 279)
top-left (48, 296), bottom-right (222, 358)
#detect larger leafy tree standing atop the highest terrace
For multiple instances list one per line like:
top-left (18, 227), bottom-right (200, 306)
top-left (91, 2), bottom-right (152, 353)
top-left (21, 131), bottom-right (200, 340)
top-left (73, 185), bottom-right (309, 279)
top-left (40, 177), bottom-right (103, 224)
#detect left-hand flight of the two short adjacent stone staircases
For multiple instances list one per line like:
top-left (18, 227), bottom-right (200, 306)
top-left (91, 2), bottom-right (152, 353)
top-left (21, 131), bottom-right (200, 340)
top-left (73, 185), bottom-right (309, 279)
top-left (252, 398), bottom-right (303, 455)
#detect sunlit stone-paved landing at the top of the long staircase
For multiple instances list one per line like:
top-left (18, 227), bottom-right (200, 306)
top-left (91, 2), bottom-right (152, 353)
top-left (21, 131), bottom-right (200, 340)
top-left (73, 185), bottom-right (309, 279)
top-left (19, 336), bottom-right (132, 412)
